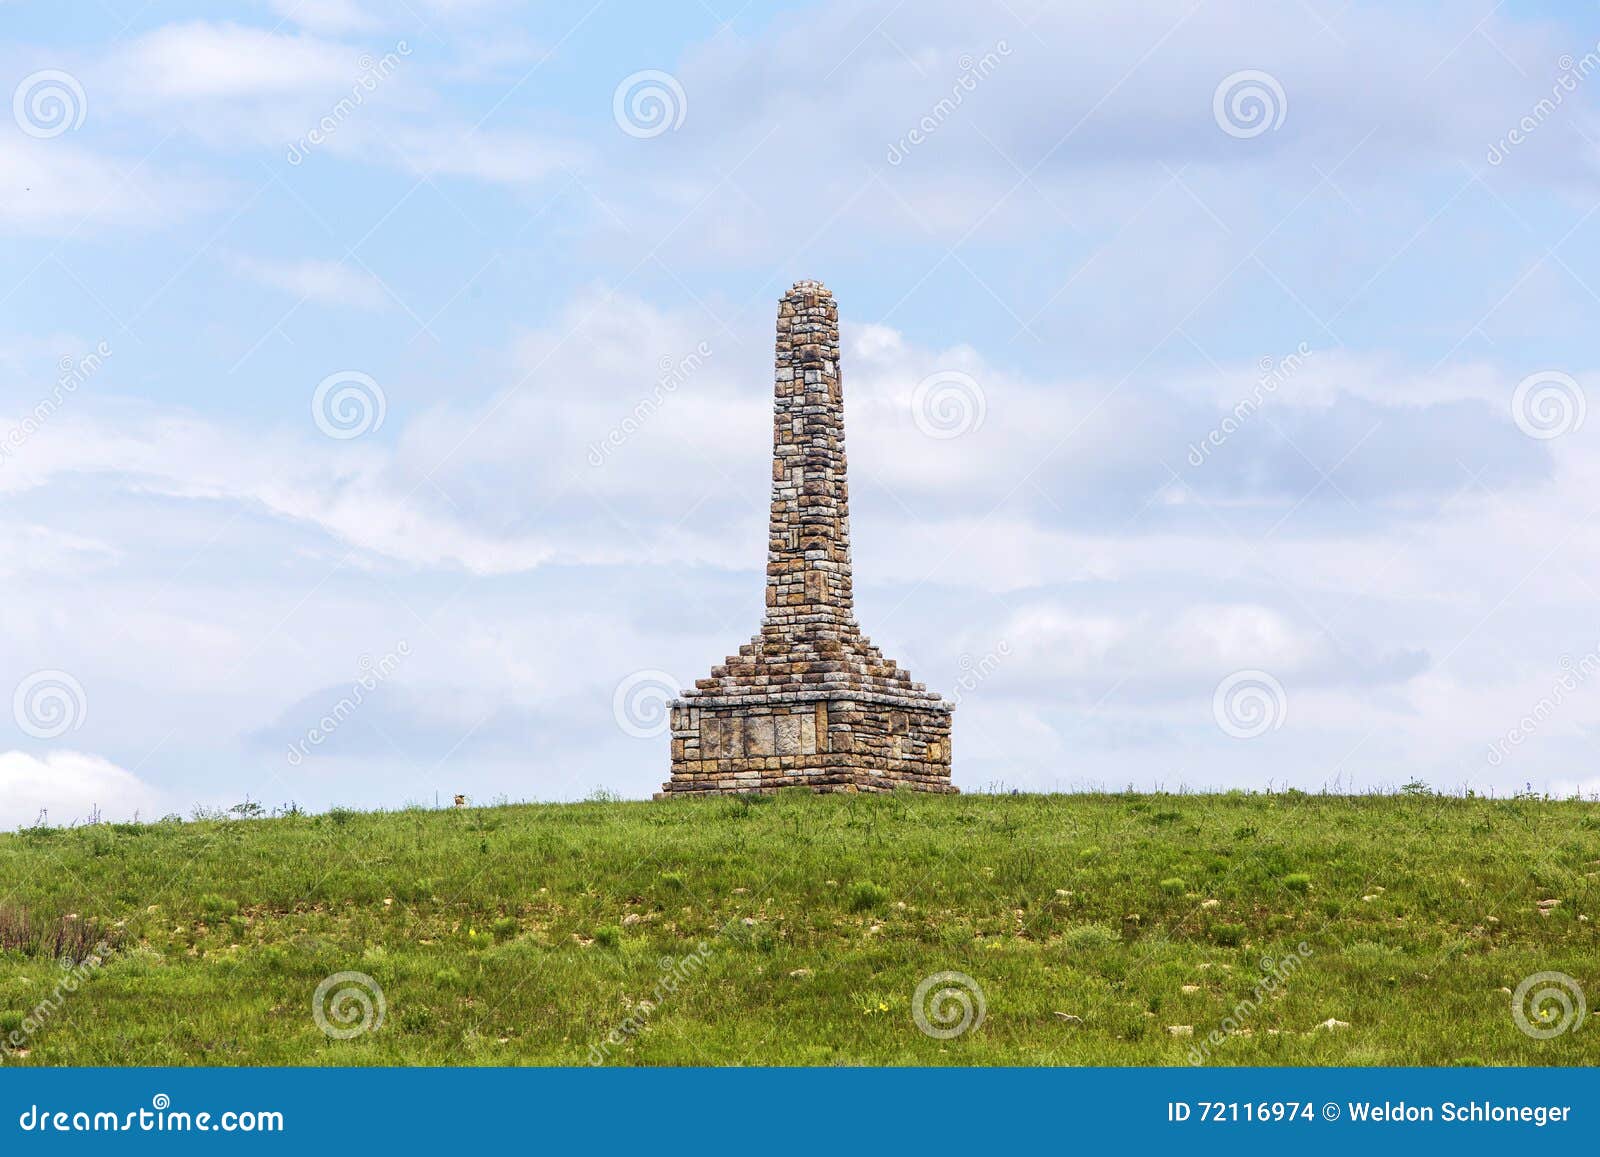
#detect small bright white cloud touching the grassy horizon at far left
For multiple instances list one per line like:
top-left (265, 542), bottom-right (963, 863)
top-left (0, 751), bottom-right (157, 827)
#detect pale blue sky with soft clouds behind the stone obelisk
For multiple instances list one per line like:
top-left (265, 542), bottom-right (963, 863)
top-left (0, 0), bottom-right (1600, 826)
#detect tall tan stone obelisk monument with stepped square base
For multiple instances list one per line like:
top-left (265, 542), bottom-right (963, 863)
top-left (656, 282), bottom-right (957, 799)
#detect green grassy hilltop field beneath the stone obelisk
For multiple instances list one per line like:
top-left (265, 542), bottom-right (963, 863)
top-left (0, 792), bottom-right (1600, 1064)
